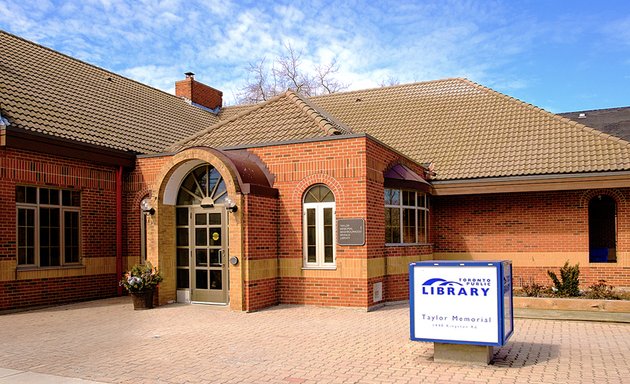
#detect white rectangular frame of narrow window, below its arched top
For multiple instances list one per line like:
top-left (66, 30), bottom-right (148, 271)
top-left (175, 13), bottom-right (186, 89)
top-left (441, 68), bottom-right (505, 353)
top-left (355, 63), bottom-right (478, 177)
top-left (302, 201), bottom-right (337, 269)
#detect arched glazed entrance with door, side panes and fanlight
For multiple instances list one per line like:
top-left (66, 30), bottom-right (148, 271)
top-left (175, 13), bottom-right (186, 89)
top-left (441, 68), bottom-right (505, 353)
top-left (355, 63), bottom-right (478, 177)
top-left (175, 163), bottom-right (229, 304)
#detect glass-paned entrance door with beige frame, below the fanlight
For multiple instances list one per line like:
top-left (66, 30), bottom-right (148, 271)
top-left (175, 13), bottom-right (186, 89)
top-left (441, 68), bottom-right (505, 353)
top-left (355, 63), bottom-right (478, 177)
top-left (190, 207), bottom-right (228, 304)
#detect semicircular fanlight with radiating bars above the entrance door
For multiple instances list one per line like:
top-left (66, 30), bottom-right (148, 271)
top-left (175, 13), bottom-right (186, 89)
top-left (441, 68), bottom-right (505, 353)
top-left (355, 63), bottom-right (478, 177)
top-left (177, 164), bottom-right (228, 206)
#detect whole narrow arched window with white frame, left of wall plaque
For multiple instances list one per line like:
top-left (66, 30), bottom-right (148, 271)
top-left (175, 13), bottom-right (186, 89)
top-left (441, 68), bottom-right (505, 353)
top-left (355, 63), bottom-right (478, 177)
top-left (302, 184), bottom-right (335, 268)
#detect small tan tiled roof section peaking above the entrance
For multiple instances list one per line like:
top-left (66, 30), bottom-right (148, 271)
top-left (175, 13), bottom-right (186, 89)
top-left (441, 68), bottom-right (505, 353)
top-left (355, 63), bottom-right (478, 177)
top-left (169, 91), bottom-right (351, 151)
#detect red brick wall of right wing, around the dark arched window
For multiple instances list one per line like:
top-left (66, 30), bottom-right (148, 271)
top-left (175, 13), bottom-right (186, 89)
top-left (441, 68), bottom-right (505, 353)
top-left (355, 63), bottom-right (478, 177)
top-left (432, 189), bottom-right (630, 288)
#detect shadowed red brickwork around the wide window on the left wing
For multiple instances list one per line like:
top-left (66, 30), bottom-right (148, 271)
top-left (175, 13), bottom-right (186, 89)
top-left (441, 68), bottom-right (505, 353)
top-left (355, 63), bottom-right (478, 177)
top-left (0, 148), bottom-right (117, 309)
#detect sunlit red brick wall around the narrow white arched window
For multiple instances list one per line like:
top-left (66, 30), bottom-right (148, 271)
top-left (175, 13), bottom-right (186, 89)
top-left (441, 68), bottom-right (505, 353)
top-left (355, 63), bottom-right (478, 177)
top-left (250, 138), bottom-right (367, 306)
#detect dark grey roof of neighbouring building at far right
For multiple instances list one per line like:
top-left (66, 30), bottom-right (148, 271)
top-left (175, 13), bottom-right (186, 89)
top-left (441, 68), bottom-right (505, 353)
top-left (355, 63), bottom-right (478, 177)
top-left (559, 107), bottom-right (630, 141)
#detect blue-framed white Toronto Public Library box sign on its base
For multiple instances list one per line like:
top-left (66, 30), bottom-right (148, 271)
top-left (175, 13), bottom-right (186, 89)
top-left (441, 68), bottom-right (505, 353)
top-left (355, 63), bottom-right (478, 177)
top-left (409, 261), bottom-right (514, 364)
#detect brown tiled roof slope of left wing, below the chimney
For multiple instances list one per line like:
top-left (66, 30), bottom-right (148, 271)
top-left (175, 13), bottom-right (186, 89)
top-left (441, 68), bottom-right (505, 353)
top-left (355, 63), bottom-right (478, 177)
top-left (0, 31), bottom-right (219, 153)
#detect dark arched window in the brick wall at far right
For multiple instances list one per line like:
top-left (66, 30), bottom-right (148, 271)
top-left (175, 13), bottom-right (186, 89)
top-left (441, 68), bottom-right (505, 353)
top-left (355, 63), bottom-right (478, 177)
top-left (588, 195), bottom-right (617, 263)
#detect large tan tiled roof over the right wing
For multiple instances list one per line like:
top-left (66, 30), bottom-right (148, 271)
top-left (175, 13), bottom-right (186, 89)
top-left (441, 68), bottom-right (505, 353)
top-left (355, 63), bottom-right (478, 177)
top-left (310, 79), bottom-right (630, 180)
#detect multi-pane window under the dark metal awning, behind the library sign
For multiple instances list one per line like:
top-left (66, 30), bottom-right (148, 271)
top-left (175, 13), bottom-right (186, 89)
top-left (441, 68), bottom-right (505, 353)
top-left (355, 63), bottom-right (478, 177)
top-left (385, 189), bottom-right (429, 244)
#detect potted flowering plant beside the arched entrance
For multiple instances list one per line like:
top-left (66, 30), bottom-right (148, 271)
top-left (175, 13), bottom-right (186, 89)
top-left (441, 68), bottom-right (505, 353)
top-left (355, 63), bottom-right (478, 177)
top-left (120, 261), bottom-right (162, 310)
